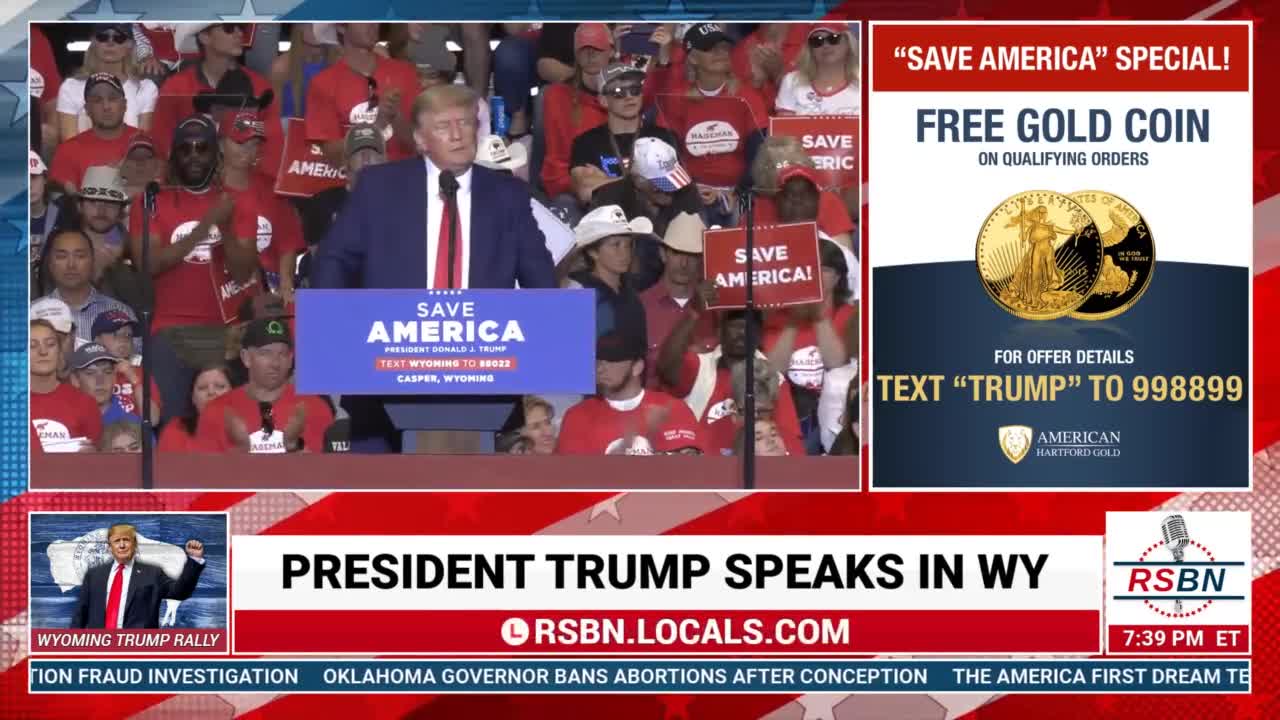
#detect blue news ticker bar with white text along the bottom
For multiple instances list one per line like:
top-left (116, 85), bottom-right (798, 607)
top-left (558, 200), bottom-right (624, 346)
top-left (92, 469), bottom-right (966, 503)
top-left (29, 660), bottom-right (1251, 693)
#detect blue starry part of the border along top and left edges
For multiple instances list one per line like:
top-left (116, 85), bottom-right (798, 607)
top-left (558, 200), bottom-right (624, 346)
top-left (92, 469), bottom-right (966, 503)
top-left (0, 0), bottom-right (836, 501)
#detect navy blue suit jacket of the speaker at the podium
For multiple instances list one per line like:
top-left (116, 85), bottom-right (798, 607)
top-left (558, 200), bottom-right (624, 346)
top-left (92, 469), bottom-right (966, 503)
top-left (310, 158), bottom-right (556, 452)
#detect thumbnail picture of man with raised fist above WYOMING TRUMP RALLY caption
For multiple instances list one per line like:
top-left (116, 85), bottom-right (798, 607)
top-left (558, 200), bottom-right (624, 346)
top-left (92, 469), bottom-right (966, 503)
top-left (31, 512), bottom-right (228, 632)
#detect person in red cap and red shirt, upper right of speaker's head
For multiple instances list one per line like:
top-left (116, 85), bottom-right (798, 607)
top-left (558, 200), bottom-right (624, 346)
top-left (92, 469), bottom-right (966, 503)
top-left (540, 23), bottom-right (613, 210)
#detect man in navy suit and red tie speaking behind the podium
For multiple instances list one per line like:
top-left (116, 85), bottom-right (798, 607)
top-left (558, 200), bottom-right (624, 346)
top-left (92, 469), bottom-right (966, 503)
top-left (311, 85), bottom-right (556, 452)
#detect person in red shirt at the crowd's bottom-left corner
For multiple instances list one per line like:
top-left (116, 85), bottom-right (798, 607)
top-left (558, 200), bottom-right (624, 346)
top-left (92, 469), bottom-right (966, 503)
top-left (29, 320), bottom-right (102, 452)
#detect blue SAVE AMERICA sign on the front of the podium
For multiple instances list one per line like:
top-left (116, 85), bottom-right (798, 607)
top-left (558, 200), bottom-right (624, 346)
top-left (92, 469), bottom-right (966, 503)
top-left (294, 290), bottom-right (596, 395)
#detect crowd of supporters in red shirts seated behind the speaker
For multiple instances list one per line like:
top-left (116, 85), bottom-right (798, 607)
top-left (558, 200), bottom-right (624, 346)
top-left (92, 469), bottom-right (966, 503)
top-left (28, 22), bottom-right (861, 455)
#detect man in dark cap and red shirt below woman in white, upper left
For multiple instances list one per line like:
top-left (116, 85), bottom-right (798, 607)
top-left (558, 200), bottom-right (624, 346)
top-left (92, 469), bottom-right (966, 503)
top-left (49, 73), bottom-right (138, 195)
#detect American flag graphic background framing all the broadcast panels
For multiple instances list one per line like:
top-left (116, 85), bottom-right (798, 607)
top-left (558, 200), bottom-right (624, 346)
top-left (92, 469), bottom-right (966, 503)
top-left (0, 0), bottom-right (1280, 720)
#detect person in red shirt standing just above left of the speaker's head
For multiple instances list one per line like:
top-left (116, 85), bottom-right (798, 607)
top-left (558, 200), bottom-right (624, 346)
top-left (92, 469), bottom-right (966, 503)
top-left (306, 23), bottom-right (419, 168)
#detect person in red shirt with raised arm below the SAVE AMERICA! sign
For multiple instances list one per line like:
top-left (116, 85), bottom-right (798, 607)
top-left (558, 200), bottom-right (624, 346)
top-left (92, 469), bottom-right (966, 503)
top-left (658, 299), bottom-right (804, 455)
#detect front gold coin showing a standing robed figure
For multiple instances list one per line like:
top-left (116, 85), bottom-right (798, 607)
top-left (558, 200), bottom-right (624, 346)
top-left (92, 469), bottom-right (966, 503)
top-left (978, 190), bottom-right (1102, 320)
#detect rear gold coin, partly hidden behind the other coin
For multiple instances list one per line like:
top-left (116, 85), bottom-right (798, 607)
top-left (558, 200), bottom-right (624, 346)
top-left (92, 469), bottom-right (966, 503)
top-left (1071, 190), bottom-right (1156, 320)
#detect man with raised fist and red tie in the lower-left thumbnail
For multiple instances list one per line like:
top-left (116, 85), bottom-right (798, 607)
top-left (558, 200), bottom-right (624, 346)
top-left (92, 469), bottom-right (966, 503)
top-left (72, 523), bottom-right (205, 630)
